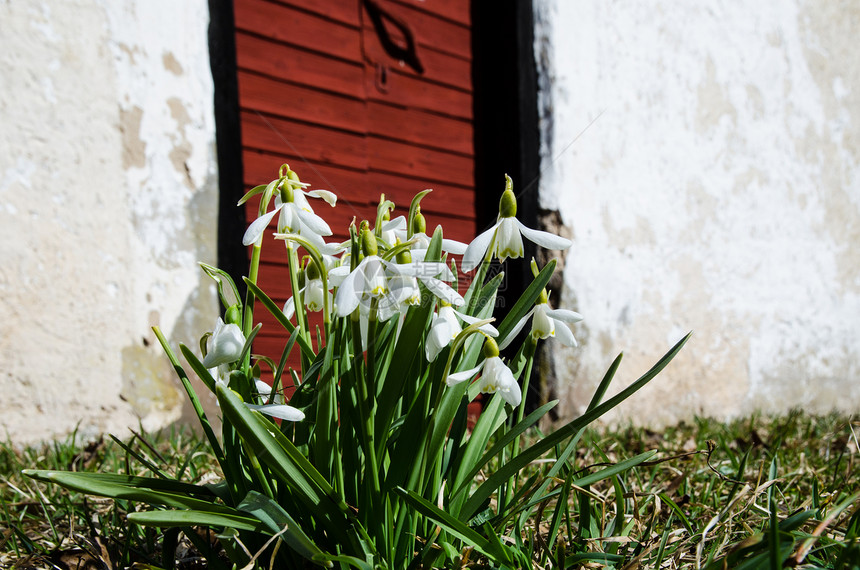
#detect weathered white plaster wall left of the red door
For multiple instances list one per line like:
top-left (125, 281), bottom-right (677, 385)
top-left (0, 0), bottom-right (218, 443)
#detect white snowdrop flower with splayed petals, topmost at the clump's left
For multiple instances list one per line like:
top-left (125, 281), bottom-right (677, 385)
top-left (242, 175), bottom-right (337, 247)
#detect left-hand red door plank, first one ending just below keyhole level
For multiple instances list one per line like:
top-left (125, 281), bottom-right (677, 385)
top-left (238, 71), bottom-right (367, 133)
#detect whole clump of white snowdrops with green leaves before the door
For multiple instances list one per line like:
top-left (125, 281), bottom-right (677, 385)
top-left (29, 165), bottom-right (686, 569)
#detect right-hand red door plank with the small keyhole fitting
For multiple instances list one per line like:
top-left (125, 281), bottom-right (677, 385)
top-left (364, 66), bottom-right (474, 121)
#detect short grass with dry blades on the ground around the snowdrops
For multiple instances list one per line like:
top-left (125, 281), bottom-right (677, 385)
top-left (0, 413), bottom-right (860, 569)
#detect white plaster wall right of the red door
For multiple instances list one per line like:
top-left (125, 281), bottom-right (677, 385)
top-left (535, 0), bottom-right (860, 424)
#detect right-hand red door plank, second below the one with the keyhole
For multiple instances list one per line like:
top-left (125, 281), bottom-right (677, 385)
top-left (367, 136), bottom-right (475, 187)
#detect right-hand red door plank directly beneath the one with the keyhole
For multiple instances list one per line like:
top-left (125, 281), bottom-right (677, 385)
top-left (367, 101), bottom-right (475, 156)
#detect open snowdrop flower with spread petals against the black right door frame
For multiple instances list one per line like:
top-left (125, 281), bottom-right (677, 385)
top-left (461, 174), bottom-right (571, 271)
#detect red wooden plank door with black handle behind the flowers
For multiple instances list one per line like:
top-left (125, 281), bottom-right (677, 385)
top-left (234, 0), bottom-right (476, 378)
